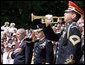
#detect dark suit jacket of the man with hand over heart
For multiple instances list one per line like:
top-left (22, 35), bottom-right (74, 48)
top-left (11, 39), bottom-right (33, 64)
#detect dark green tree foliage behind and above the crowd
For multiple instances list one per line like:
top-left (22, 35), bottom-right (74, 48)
top-left (1, 1), bottom-right (84, 29)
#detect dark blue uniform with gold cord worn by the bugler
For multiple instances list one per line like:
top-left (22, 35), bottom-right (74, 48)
top-left (43, 22), bottom-right (81, 64)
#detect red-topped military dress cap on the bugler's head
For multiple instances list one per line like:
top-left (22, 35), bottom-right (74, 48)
top-left (65, 1), bottom-right (84, 15)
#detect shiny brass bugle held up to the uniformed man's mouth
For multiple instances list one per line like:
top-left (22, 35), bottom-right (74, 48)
top-left (31, 13), bottom-right (64, 24)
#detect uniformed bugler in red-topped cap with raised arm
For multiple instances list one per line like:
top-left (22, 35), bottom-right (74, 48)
top-left (43, 1), bottom-right (84, 64)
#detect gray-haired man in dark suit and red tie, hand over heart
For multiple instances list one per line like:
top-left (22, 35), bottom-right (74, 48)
top-left (11, 29), bottom-right (33, 64)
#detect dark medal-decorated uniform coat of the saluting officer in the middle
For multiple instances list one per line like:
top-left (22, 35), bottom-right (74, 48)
top-left (34, 38), bottom-right (53, 64)
